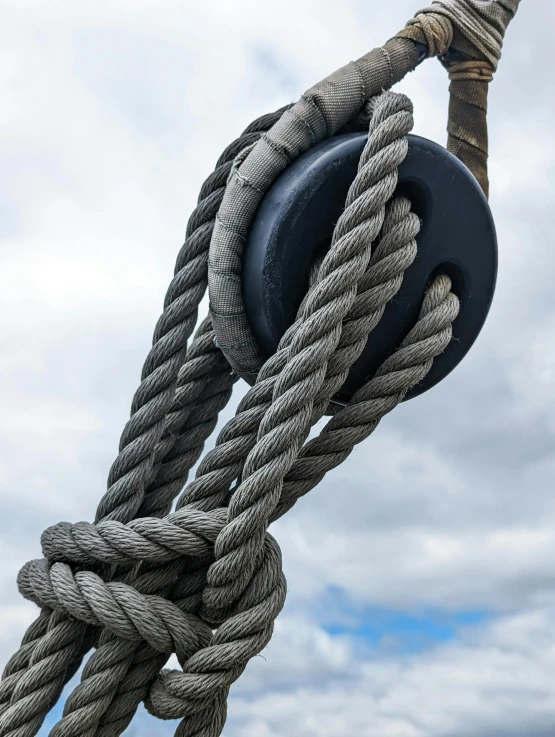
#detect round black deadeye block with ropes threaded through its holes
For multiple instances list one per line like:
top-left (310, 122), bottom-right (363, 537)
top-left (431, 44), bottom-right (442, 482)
top-left (242, 133), bottom-right (497, 403)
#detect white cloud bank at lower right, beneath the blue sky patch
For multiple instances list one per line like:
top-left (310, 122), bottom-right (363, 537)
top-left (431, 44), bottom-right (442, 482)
top-left (223, 610), bottom-right (555, 737)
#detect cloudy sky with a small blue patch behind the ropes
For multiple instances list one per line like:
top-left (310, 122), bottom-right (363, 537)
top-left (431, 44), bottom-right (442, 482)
top-left (0, 0), bottom-right (555, 737)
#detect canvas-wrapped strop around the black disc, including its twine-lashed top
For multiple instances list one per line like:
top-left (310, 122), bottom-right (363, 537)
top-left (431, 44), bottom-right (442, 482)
top-left (208, 0), bottom-right (519, 384)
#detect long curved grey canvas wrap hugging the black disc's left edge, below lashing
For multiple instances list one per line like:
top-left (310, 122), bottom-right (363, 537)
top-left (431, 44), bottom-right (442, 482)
top-left (208, 38), bottom-right (418, 384)
